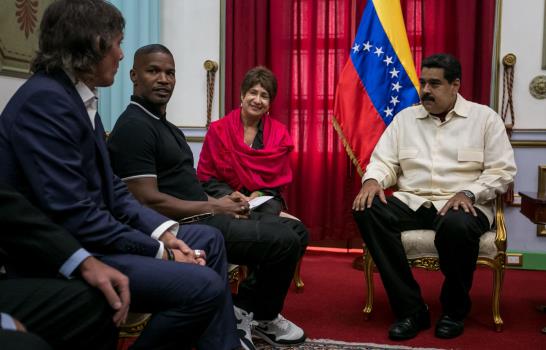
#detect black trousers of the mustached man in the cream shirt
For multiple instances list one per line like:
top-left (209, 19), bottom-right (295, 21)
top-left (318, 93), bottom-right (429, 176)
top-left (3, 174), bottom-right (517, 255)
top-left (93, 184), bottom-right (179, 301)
top-left (353, 197), bottom-right (490, 319)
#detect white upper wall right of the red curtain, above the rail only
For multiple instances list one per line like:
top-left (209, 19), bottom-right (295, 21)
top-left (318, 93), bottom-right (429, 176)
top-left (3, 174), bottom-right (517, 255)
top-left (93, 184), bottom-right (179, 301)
top-left (499, 0), bottom-right (546, 130)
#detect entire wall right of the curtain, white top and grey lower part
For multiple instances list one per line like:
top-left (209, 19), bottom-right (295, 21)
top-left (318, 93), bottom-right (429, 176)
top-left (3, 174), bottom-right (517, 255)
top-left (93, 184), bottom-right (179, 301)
top-left (498, 0), bottom-right (546, 253)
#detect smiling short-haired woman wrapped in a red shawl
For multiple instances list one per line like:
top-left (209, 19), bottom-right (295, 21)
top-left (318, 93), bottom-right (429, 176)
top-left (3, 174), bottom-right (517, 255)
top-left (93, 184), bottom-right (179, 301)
top-left (197, 67), bottom-right (294, 215)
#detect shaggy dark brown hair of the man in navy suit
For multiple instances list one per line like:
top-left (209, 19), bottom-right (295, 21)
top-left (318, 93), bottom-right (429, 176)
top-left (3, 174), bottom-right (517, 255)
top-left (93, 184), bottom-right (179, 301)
top-left (31, 0), bottom-right (125, 75)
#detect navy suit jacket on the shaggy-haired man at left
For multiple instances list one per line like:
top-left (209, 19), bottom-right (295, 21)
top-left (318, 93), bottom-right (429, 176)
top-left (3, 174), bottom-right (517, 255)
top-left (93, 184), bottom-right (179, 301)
top-left (0, 71), bottom-right (168, 256)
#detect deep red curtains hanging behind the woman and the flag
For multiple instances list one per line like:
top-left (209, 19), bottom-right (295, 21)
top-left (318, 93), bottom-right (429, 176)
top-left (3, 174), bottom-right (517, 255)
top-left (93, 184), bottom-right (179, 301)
top-left (225, 0), bottom-right (494, 246)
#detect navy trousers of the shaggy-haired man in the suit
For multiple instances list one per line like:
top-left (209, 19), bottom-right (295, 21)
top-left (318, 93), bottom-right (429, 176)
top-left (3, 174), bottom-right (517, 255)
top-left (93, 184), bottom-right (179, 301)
top-left (101, 225), bottom-right (240, 350)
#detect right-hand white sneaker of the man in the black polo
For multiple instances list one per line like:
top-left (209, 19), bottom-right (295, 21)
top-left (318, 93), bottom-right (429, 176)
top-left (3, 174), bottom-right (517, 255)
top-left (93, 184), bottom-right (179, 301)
top-left (254, 314), bottom-right (306, 346)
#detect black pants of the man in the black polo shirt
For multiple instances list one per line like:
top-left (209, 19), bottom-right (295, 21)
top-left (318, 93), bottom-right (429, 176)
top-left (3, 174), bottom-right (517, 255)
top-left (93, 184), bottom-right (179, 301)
top-left (203, 212), bottom-right (308, 320)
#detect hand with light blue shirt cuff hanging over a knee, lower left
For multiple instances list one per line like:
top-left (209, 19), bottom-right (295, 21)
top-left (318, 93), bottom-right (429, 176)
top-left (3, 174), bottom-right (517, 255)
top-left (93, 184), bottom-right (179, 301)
top-left (79, 256), bottom-right (131, 326)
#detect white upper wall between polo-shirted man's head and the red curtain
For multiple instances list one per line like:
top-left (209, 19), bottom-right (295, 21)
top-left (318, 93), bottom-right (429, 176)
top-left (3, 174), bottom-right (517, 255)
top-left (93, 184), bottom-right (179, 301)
top-left (161, 0), bottom-right (222, 129)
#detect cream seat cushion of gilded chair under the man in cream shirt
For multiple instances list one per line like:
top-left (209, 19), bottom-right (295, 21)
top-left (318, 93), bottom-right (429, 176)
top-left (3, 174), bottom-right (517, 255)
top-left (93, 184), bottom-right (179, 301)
top-left (402, 230), bottom-right (497, 259)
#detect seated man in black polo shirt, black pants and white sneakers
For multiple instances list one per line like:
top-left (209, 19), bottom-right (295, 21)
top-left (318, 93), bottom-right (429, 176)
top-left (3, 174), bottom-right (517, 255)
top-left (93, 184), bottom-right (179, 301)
top-left (108, 44), bottom-right (308, 349)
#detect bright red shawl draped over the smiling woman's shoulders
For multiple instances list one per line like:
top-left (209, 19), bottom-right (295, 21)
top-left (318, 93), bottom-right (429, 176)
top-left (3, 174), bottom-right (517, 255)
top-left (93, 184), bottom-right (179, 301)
top-left (197, 108), bottom-right (294, 192)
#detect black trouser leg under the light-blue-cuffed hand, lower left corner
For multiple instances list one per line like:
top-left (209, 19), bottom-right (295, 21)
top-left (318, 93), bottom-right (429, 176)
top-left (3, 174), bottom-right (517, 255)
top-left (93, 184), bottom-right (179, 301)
top-left (0, 278), bottom-right (117, 350)
